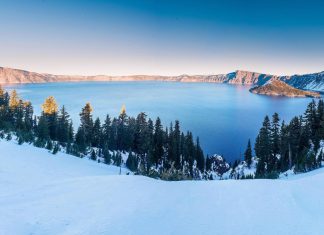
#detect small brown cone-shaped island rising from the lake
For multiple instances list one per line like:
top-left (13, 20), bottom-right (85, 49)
top-left (250, 80), bottom-right (321, 98)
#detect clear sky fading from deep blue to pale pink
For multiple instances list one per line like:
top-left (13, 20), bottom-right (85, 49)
top-left (0, 0), bottom-right (324, 75)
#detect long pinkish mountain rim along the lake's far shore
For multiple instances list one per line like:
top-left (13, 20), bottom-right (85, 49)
top-left (0, 67), bottom-right (324, 92)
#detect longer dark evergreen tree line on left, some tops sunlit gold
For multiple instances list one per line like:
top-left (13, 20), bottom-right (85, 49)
top-left (0, 88), bottom-right (205, 180)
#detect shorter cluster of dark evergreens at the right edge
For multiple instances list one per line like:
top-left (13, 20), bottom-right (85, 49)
top-left (244, 100), bottom-right (324, 178)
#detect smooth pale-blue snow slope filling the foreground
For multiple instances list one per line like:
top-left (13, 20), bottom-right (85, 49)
top-left (0, 140), bottom-right (324, 235)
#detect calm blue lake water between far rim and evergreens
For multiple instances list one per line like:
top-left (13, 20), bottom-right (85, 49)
top-left (8, 82), bottom-right (311, 161)
